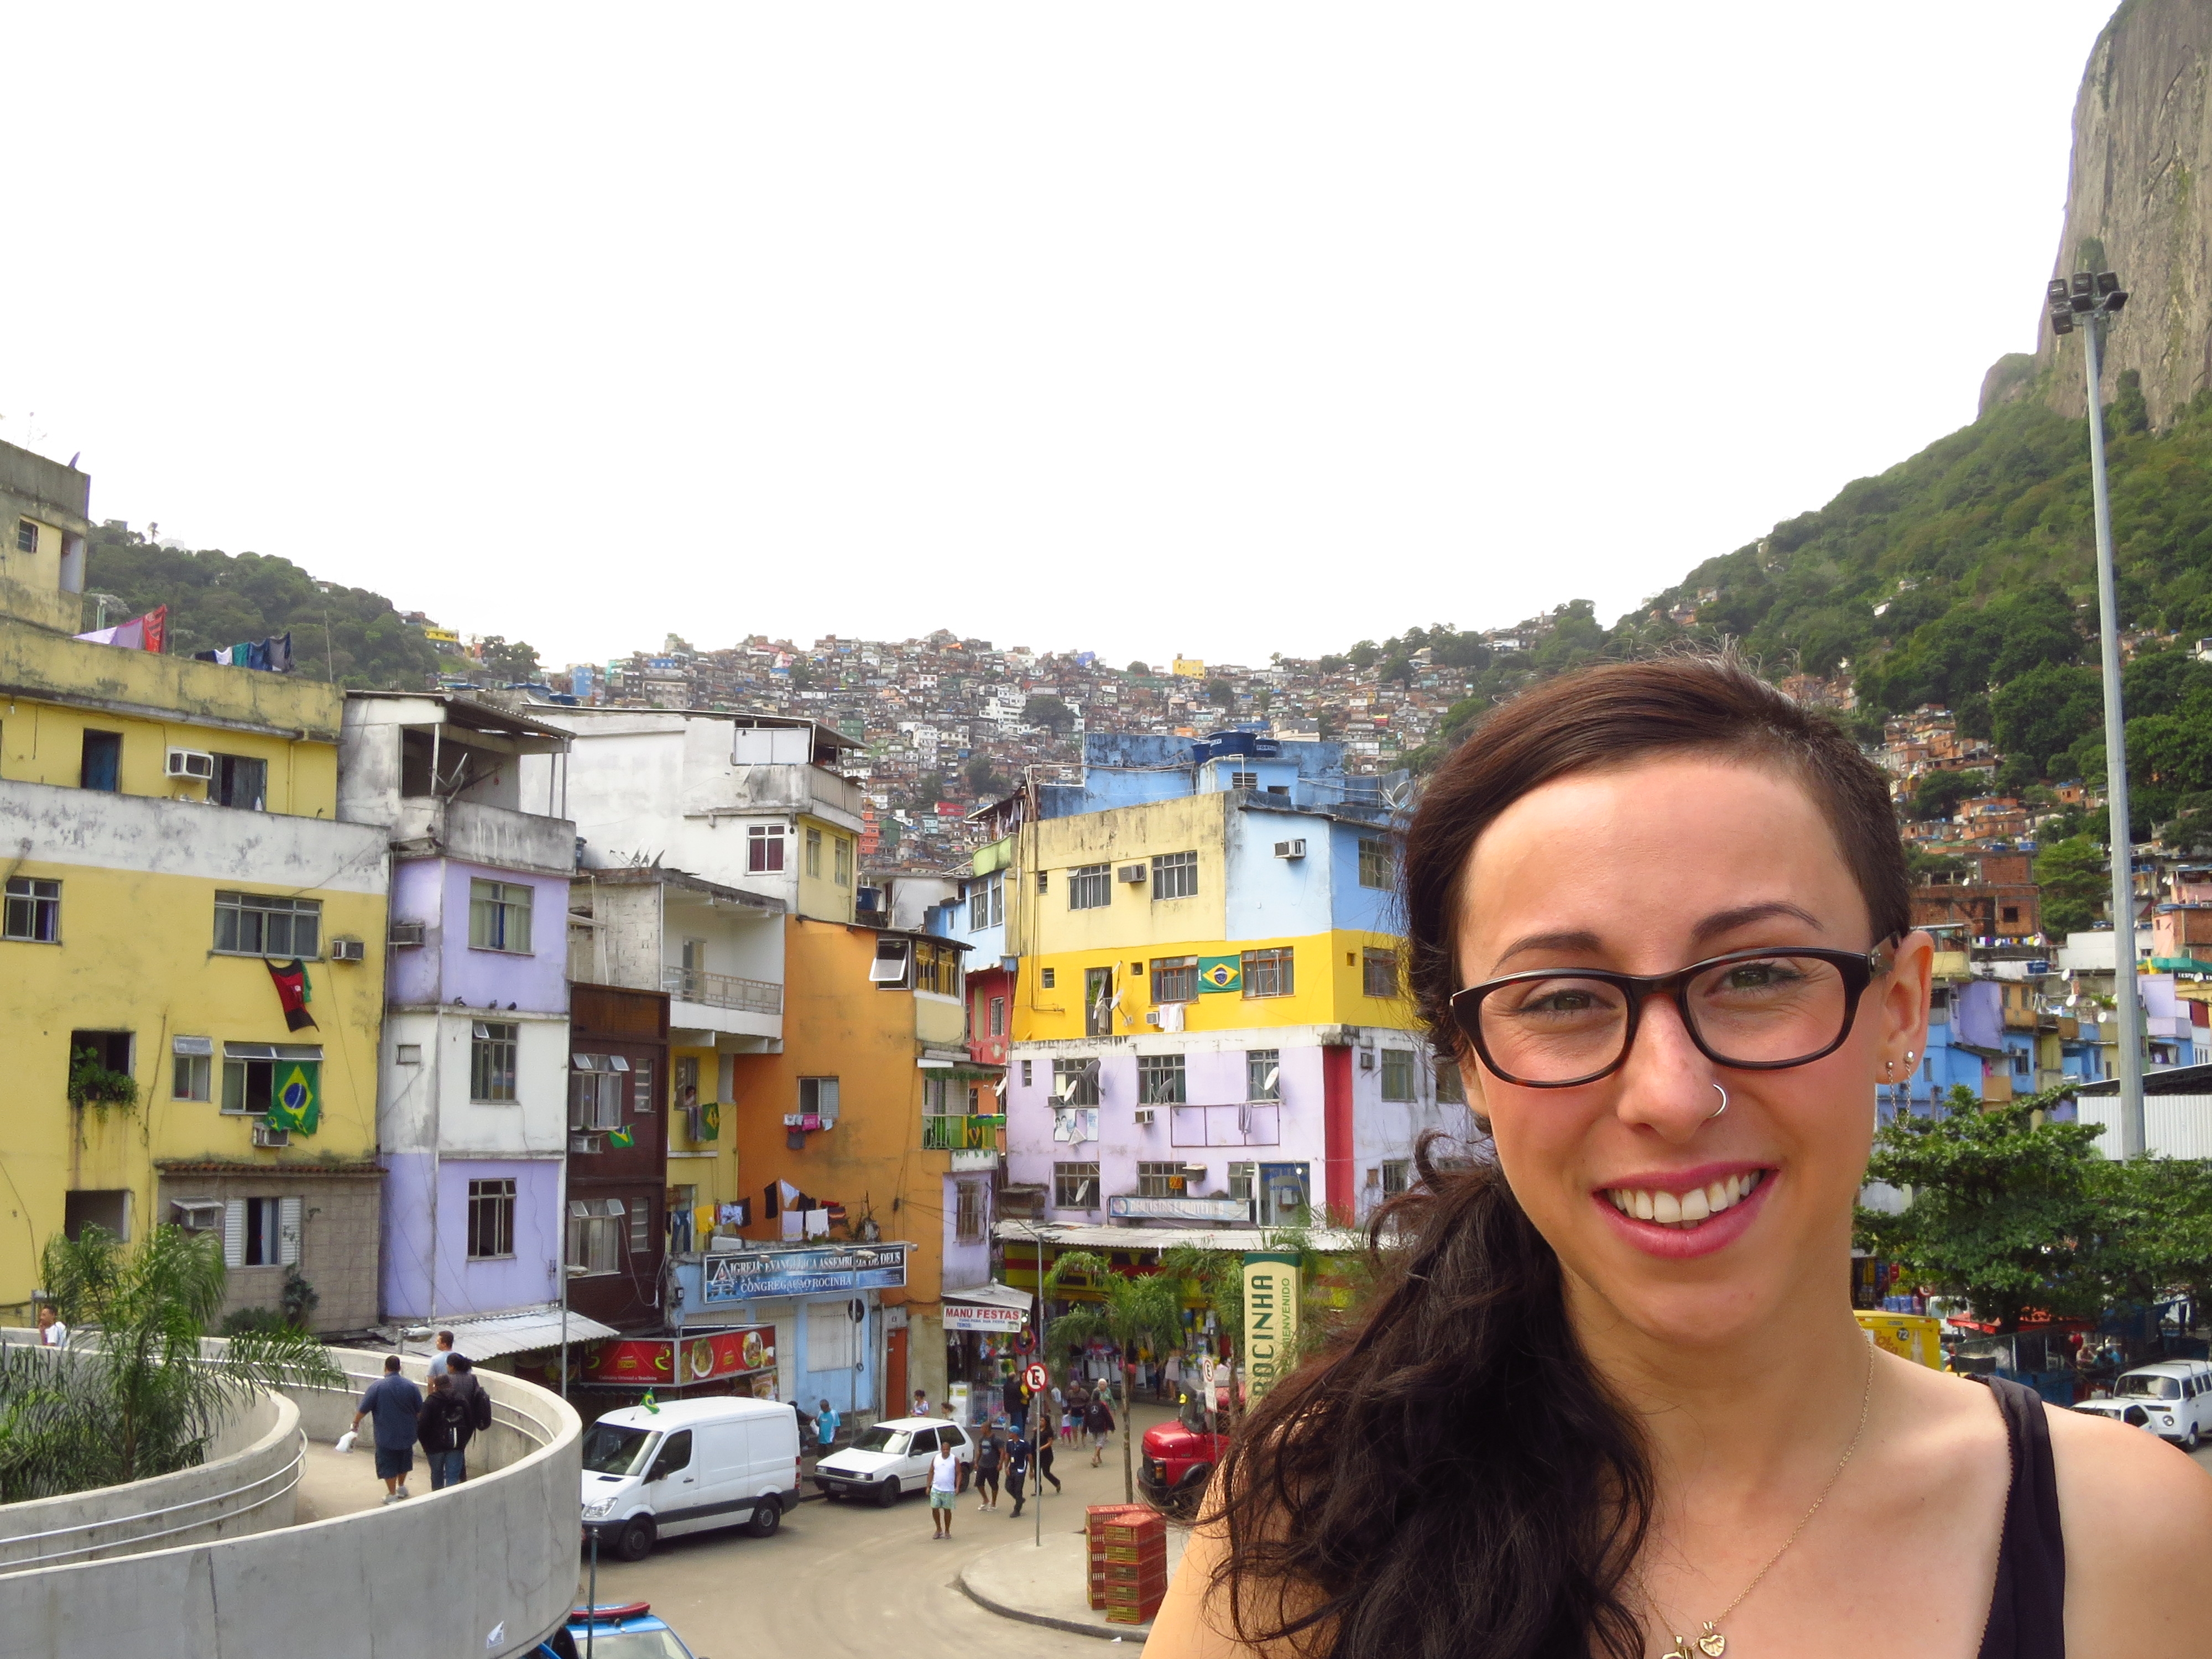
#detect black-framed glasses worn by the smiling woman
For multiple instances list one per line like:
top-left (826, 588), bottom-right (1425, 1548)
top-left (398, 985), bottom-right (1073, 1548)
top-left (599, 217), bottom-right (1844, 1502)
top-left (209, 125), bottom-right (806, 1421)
top-left (1451, 945), bottom-right (1889, 1088)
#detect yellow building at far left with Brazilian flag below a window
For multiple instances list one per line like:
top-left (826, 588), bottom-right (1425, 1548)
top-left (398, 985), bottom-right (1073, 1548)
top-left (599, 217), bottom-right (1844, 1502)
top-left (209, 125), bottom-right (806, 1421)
top-left (0, 445), bottom-right (387, 1332)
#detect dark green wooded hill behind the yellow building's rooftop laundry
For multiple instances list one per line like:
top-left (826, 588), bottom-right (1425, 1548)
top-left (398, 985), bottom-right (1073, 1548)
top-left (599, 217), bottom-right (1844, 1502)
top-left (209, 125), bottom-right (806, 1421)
top-left (86, 526), bottom-right (438, 690)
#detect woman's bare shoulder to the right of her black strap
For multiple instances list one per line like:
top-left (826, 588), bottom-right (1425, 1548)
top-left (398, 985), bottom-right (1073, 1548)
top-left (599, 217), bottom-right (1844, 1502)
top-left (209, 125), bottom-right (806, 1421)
top-left (2044, 1407), bottom-right (2212, 1659)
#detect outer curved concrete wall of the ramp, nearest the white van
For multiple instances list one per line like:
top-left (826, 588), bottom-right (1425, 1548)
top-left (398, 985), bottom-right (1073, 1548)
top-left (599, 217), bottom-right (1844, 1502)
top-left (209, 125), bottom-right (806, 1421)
top-left (0, 1349), bottom-right (582, 1659)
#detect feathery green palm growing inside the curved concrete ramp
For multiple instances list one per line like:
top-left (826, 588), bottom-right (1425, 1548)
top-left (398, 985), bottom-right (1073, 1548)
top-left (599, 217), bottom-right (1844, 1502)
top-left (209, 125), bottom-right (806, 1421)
top-left (40, 1228), bottom-right (345, 1489)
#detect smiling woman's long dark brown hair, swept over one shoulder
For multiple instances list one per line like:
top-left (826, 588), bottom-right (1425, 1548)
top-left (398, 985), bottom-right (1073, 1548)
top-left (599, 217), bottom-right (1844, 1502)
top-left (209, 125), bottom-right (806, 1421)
top-left (1206, 657), bottom-right (1911, 1659)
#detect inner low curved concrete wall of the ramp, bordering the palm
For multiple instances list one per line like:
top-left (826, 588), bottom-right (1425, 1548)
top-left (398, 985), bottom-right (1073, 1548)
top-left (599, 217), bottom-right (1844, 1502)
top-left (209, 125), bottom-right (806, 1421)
top-left (0, 1354), bottom-right (303, 1573)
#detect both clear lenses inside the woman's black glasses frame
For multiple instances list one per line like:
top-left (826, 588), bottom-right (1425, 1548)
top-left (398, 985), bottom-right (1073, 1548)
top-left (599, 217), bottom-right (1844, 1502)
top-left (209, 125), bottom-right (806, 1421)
top-left (1475, 956), bottom-right (1849, 1082)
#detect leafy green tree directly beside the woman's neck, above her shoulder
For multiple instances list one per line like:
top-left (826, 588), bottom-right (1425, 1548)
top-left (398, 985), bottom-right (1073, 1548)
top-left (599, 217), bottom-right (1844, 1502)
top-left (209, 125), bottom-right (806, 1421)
top-left (1858, 1088), bottom-right (2106, 1332)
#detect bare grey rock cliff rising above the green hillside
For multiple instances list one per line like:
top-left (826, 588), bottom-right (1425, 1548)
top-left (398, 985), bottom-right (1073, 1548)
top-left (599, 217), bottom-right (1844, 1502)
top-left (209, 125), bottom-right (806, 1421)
top-left (2035, 0), bottom-right (2212, 425)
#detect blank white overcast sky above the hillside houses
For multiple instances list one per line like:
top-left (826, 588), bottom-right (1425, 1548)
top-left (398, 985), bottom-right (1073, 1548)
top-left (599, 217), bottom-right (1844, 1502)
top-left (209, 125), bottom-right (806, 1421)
top-left (0, 0), bottom-right (2112, 664)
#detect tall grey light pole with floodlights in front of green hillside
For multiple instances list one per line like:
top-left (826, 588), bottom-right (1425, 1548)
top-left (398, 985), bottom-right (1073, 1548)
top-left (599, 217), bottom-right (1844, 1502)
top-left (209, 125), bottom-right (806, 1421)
top-left (2044, 270), bottom-right (2143, 1157)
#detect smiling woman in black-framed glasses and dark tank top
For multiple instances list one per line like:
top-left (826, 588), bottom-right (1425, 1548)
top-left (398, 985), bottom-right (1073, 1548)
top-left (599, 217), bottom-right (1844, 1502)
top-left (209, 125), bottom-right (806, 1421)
top-left (1148, 659), bottom-right (2212, 1659)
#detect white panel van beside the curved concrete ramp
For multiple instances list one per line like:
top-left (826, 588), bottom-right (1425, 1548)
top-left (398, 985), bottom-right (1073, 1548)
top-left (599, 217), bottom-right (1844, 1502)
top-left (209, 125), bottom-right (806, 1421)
top-left (584, 1396), bottom-right (799, 1562)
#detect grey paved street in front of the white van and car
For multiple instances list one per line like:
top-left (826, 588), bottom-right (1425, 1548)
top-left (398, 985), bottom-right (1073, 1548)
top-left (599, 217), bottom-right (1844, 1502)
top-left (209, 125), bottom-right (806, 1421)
top-left (577, 1405), bottom-right (1170, 1659)
